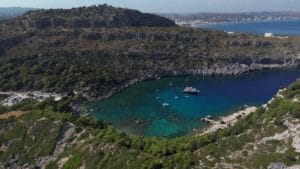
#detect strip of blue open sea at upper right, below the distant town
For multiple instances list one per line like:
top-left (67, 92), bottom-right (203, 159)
top-left (197, 20), bottom-right (300, 35)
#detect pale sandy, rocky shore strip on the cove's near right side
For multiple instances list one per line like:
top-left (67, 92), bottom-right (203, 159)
top-left (197, 106), bottom-right (257, 135)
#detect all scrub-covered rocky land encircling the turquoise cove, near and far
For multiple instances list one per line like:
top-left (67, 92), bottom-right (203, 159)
top-left (0, 5), bottom-right (300, 169)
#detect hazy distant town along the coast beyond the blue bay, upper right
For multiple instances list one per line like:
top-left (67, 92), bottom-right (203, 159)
top-left (160, 12), bottom-right (300, 26)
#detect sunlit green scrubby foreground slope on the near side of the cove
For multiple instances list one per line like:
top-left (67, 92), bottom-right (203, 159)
top-left (0, 80), bottom-right (300, 169)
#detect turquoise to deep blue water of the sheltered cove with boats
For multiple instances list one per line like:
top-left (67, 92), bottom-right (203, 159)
top-left (84, 68), bottom-right (300, 138)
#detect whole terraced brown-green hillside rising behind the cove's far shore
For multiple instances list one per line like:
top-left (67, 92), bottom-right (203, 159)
top-left (0, 6), bottom-right (300, 98)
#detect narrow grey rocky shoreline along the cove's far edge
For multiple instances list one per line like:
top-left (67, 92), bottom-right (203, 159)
top-left (77, 60), bottom-right (298, 100)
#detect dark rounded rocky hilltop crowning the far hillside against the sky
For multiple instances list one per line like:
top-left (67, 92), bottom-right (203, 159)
top-left (12, 5), bottom-right (176, 29)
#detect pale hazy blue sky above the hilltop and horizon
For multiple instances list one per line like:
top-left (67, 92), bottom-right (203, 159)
top-left (0, 0), bottom-right (300, 13)
